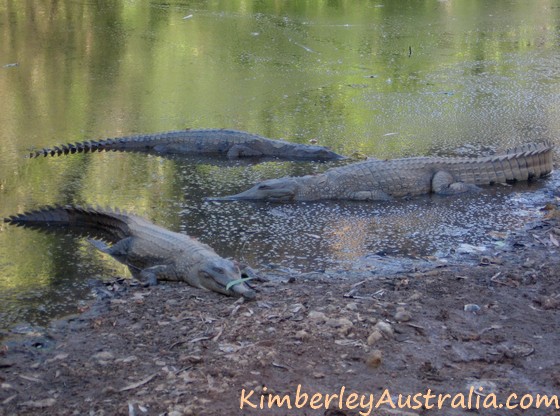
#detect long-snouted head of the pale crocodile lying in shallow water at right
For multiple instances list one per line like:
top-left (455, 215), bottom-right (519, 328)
top-left (207, 177), bottom-right (299, 202)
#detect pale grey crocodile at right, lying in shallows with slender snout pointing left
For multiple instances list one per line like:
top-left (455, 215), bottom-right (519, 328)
top-left (207, 142), bottom-right (553, 202)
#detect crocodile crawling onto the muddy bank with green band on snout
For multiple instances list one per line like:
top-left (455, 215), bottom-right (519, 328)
top-left (4, 205), bottom-right (256, 300)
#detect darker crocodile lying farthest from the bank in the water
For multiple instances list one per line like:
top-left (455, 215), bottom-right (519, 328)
top-left (29, 129), bottom-right (344, 160)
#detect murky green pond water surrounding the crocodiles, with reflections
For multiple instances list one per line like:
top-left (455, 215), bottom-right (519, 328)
top-left (0, 0), bottom-right (560, 327)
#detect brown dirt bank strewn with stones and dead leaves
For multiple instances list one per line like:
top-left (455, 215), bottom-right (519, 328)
top-left (0, 211), bottom-right (560, 416)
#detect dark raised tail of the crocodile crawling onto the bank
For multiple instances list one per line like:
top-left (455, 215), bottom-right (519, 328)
top-left (4, 205), bottom-right (130, 242)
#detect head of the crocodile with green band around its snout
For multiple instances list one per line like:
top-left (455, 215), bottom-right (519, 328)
top-left (198, 257), bottom-right (256, 299)
